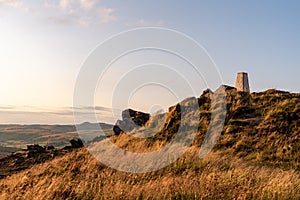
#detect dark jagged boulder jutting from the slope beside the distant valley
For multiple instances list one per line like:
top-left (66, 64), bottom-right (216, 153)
top-left (113, 109), bottom-right (150, 135)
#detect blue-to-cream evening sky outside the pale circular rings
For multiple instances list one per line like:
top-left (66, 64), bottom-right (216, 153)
top-left (0, 0), bottom-right (300, 123)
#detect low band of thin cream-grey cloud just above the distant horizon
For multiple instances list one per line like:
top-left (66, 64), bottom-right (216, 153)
top-left (0, 106), bottom-right (120, 124)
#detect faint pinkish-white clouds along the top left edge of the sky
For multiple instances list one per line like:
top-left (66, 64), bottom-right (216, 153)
top-left (0, 0), bottom-right (117, 27)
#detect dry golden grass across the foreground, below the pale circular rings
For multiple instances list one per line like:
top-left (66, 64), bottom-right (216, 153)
top-left (0, 147), bottom-right (300, 200)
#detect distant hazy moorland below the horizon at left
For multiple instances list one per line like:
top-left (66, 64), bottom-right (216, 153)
top-left (0, 122), bottom-right (112, 157)
